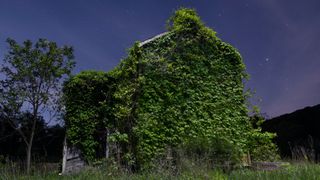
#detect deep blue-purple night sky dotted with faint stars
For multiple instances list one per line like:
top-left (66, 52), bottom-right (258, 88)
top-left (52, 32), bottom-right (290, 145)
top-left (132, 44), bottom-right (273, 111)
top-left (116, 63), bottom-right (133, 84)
top-left (0, 0), bottom-right (320, 117)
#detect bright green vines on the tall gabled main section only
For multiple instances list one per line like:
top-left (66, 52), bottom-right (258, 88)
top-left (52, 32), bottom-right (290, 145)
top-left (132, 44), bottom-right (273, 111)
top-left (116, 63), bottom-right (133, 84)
top-left (116, 9), bottom-right (254, 169)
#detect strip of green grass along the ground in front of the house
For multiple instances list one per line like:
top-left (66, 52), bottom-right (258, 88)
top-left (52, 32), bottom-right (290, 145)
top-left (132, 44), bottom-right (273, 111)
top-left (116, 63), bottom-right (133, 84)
top-left (0, 163), bottom-right (320, 180)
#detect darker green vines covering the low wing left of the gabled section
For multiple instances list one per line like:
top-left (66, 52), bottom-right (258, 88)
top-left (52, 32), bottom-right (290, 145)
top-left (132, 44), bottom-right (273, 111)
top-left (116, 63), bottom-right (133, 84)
top-left (63, 71), bottom-right (113, 160)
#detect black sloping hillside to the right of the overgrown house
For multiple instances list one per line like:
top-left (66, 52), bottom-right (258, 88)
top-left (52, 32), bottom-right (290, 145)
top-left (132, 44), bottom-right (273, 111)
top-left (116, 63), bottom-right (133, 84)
top-left (262, 104), bottom-right (320, 161)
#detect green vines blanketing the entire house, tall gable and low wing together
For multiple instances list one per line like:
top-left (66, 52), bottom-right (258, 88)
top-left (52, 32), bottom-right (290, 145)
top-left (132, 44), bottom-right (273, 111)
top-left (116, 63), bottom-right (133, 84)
top-left (64, 9), bottom-right (275, 170)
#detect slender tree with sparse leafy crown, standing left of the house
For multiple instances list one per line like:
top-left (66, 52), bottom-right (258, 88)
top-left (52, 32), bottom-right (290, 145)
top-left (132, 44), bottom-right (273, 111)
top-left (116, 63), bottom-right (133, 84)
top-left (0, 38), bottom-right (75, 173)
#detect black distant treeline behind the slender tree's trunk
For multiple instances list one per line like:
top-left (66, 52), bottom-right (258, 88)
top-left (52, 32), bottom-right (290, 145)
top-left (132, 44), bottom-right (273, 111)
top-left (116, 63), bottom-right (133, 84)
top-left (0, 113), bottom-right (65, 163)
